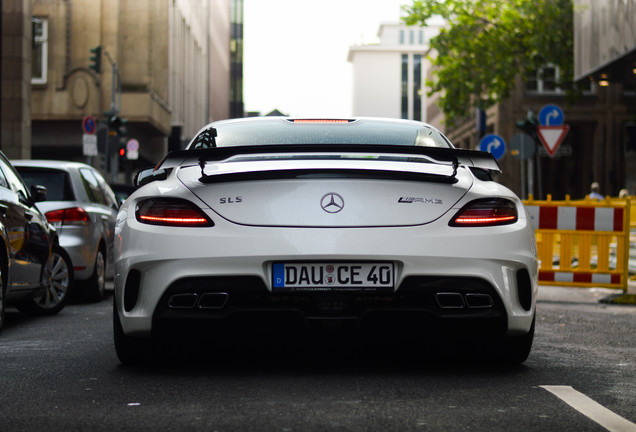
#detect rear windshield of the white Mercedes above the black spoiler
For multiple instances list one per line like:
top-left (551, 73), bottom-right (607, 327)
top-left (188, 119), bottom-right (452, 149)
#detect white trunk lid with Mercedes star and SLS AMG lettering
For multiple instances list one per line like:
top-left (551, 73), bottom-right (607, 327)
top-left (177, 161), bottom-right (472, 227)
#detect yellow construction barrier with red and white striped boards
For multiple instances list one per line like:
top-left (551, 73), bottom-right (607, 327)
top-left (524, 196), bottom-right (631, 292)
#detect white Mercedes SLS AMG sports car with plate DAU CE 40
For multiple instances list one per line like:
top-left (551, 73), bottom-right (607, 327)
top-left (113, 117), bottom-right (537, 363)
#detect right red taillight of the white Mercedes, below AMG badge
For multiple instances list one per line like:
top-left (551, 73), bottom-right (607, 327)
top-left (449, 198), bottom-right (518, 227)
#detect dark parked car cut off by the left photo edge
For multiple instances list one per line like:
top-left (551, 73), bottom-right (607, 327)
top-left (0, 152), bottom-right (73, 329)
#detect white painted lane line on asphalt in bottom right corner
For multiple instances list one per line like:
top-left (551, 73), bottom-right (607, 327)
top-left (539, 386), bottom-right (636, 432)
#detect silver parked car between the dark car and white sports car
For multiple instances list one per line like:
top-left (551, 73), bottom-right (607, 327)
top-left (12, 160), bottom-right (118, 301)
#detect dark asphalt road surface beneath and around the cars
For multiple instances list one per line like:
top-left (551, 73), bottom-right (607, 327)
top-left (0, 287), bottom-right (636, 432)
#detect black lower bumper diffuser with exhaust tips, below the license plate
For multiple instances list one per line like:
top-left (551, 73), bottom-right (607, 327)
top-left (152, 277), bottom-right (507, 339)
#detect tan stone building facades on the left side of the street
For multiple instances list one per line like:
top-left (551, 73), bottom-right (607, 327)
top-left (2, 0), bottom-right (242, 182)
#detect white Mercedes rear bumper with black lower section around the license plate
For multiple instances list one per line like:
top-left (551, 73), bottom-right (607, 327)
top-left (114, 214), bottom-right (537, 337)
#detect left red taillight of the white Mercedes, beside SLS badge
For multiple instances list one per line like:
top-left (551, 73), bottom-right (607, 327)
top-left (135, 198), bottom-right (214, 227)
